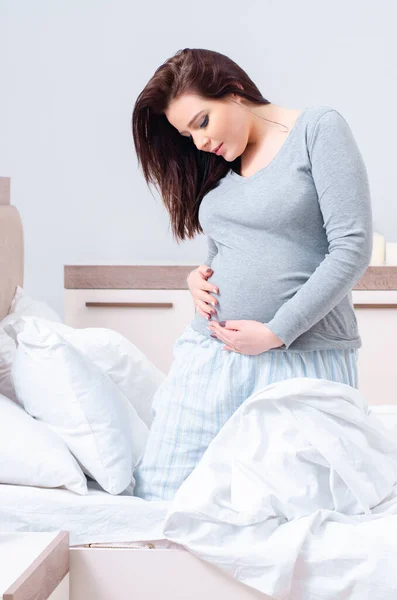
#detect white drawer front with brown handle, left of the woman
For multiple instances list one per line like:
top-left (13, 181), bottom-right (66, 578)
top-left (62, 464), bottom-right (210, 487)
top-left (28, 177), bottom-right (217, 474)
top-left (64, 289), bottom-right (195, 373)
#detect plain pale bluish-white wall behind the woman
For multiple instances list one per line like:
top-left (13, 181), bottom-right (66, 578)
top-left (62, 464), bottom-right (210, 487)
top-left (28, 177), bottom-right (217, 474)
top-left (0, 0), bottom-right (397, 315)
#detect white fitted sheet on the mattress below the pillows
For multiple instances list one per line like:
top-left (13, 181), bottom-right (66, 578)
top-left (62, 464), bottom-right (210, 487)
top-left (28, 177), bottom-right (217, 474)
top-left (0, 481), bottom-right (169, 546)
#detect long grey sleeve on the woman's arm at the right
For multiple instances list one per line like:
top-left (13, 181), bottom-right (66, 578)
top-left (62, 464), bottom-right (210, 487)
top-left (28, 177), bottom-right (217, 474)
top-left (265, 109), bottom-right (373, 348)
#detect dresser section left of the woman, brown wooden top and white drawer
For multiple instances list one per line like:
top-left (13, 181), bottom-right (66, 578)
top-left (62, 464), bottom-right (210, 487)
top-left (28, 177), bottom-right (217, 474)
top-left (65, 265), bottom-right (197, 373)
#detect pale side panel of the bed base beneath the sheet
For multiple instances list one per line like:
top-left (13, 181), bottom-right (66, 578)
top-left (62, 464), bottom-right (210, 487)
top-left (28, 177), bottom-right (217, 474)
top-left (69, 542), bottom-right (271, 600)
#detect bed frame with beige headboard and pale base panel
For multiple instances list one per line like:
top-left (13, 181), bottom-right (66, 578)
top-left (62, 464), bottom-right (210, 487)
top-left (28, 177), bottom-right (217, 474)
top-left (0, 177), bottom-right (270, 600)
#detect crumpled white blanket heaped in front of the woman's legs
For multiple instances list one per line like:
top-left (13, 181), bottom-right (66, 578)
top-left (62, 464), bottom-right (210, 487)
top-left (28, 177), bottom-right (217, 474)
top-left (164, 377), bottom-right (397, 600)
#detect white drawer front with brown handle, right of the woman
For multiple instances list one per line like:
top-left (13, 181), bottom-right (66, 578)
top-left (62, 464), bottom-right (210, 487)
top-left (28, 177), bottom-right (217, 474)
top-left (352, 290), bottom-right (397, 404)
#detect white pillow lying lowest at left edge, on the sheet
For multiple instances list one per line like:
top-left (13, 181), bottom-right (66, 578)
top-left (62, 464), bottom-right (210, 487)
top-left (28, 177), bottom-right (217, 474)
top-left (0, 394), bottom-right (88, 495)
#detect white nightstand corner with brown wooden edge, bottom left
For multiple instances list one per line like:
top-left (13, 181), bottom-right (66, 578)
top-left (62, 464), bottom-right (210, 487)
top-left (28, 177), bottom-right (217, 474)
top-left (0, 531), bottom-right (69, 600)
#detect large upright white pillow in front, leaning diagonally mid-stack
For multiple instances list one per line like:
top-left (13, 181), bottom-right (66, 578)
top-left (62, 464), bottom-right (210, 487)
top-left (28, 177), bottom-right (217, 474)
top-left (7, 317), bottom-right (148, 494)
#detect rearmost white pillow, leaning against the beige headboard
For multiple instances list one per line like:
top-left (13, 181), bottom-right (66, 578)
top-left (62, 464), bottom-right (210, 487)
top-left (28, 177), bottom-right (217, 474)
top-left (0, 286), bottom-right (62, 402)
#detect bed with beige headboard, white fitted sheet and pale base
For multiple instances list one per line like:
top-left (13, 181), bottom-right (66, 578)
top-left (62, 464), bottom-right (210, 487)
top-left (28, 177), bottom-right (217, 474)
top-left (0, 178), bottom-right (397, 600)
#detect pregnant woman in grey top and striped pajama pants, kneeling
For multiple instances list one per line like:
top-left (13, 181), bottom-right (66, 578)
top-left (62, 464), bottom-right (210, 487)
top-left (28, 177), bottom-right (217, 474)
top-left (132, 48), bottom-right (372, 500)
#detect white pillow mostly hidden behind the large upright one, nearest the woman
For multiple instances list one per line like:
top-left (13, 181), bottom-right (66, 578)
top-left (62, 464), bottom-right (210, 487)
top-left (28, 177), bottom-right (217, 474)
top-left (6, 318), bottom-right (166, 427)
